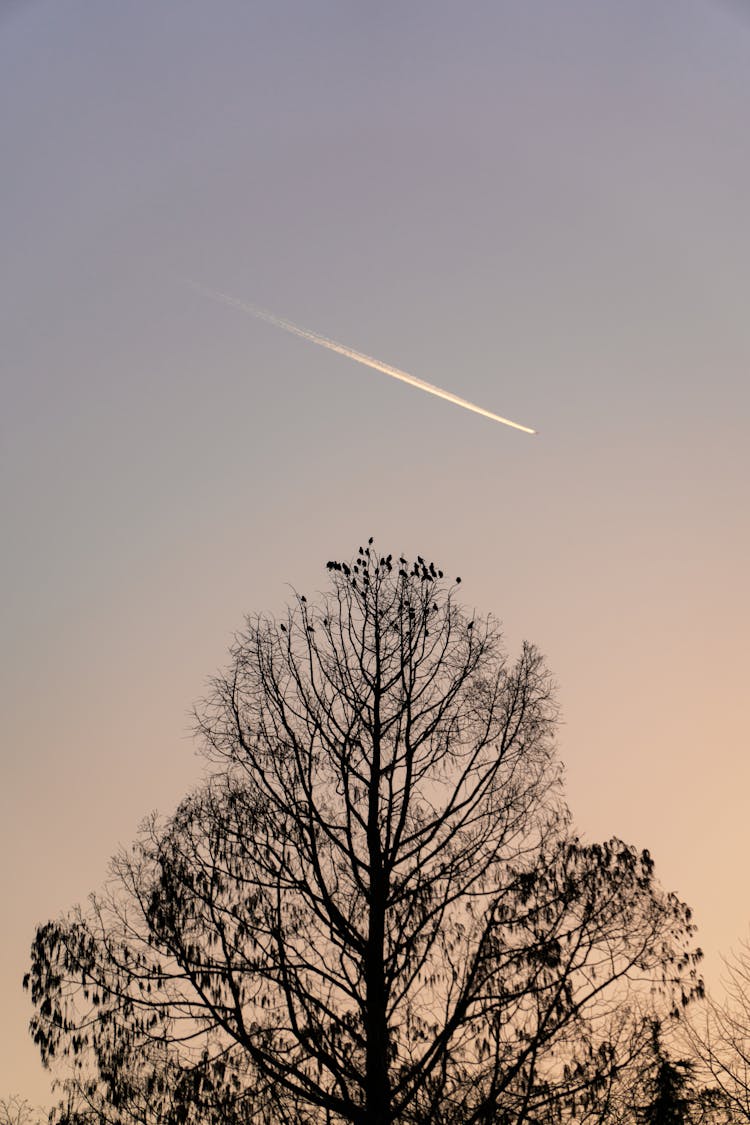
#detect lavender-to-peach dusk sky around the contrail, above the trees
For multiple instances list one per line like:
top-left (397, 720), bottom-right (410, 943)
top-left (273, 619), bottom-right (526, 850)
top-left (0, 0), bottom-right (750, 1104)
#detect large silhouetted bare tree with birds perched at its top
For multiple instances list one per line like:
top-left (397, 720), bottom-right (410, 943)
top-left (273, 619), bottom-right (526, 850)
top-left (27, 542), bottom-right (701, 1125)
